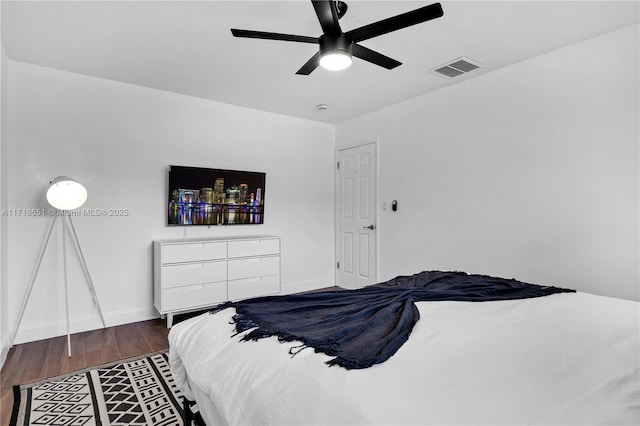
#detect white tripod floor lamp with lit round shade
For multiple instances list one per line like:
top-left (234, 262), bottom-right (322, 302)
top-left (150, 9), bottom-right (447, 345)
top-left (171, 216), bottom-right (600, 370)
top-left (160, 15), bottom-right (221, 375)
top-left (11, 176), bottom-right (106, 357)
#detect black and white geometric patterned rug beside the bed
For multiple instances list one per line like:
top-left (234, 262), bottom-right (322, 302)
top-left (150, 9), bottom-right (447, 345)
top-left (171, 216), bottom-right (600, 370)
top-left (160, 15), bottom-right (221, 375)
top-left (10, 351), bottom-right (188, 426)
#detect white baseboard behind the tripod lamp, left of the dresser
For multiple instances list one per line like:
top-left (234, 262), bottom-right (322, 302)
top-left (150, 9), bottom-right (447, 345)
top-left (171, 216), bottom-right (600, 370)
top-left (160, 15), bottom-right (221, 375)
top-left (12, 306), bottom-right (160, 344)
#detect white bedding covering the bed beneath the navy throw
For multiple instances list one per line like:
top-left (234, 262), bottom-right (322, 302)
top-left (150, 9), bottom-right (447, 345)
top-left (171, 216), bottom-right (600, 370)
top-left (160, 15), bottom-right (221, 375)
top-left (169, 293), bottom-right (640, 426)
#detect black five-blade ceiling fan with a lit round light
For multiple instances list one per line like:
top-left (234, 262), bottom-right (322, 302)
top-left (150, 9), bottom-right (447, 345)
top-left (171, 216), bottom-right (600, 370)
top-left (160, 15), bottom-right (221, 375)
top-left (231, 0), bottom-right (443, 75)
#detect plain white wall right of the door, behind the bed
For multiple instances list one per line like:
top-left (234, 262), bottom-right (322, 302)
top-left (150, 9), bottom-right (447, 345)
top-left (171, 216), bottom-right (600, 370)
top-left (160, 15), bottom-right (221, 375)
top-left (336, 25), bottom-right (640, 300)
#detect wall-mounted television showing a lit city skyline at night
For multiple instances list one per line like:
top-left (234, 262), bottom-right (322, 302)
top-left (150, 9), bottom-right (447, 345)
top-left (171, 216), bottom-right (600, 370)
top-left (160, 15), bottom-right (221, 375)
top-left (167, 166), bottom-right (266, 225)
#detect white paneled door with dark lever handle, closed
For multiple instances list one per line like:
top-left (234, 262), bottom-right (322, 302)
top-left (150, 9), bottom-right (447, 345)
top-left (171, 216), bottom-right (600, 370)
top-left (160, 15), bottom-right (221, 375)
top-left (337, 144), bottom-right (377, 288)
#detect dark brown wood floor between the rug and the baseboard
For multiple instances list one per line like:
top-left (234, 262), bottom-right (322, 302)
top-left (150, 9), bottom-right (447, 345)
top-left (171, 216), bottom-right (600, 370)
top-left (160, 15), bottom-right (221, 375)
top-left (0, 319), bottom-right (169, 425)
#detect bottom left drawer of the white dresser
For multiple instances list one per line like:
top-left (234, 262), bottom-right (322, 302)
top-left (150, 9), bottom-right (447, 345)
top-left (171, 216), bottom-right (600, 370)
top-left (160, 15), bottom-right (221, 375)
top-left (162, 282), bottom-right (227, 312)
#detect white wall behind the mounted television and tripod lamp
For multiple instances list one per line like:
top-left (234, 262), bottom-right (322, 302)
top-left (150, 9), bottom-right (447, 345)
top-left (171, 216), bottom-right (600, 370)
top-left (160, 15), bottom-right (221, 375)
top-left (8, 61), bottom-right (334, 342)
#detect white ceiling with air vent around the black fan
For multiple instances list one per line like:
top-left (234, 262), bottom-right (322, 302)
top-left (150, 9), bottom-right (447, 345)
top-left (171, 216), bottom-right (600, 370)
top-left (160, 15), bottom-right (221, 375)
top-left (1, 0), bottom-right (640, 123)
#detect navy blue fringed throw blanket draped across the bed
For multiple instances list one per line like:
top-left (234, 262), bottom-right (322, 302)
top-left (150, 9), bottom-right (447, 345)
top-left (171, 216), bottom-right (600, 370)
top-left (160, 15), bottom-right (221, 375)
top-left (211, 271), bottom-right (575, 369)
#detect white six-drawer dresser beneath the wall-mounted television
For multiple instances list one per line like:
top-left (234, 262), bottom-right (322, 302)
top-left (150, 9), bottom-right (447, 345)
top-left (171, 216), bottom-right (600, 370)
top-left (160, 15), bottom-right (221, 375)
top-left (153, 235), bottom-right (280, 327)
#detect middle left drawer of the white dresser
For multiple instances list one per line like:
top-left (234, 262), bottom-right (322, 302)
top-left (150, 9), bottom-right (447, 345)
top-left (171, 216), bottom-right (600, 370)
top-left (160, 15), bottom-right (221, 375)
top-left (162, 260), bottom-right (227, 288)
